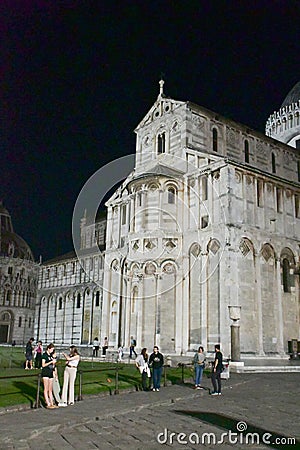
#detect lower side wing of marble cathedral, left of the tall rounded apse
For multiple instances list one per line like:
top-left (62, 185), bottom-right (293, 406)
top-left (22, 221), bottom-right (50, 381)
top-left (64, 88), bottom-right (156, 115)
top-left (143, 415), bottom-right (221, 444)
top-left (35, 217), bottom-right (106, 345)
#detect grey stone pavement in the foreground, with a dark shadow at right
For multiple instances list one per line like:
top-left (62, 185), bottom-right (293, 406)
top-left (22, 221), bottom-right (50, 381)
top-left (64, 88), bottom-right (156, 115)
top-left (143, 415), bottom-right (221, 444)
top-left (0, 373), bottom-right (300, 450)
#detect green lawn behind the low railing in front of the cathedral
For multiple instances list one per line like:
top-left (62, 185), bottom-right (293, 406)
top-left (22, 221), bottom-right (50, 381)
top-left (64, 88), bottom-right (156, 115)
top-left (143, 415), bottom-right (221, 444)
top-left (0, 347), bottom-right (193, 408)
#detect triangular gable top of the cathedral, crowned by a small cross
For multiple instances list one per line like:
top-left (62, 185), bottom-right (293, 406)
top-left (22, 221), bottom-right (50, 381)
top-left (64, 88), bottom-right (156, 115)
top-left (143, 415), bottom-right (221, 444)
top-left (135, 81), bottom-right (187, 132)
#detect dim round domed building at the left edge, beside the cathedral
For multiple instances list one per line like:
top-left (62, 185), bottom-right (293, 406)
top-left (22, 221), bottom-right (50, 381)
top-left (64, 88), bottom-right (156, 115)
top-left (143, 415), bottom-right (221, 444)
top-left (0, 203), bottom-right (39, 344)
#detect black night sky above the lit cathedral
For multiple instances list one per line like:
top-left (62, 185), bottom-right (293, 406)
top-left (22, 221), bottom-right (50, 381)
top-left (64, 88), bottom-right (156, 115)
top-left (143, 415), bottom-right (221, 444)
top-left (0, 0), bottom-right (300, 260)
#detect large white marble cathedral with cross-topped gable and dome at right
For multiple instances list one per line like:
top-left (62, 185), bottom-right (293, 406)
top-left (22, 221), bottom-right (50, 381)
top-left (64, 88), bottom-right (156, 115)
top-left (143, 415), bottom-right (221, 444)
top-left (35, 81), bottom-right (300, 356)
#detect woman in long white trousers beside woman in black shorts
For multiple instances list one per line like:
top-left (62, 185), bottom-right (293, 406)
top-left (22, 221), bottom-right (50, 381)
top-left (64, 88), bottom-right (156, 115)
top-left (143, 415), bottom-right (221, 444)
top-left (58, 345), bottom-right (80, 406)
